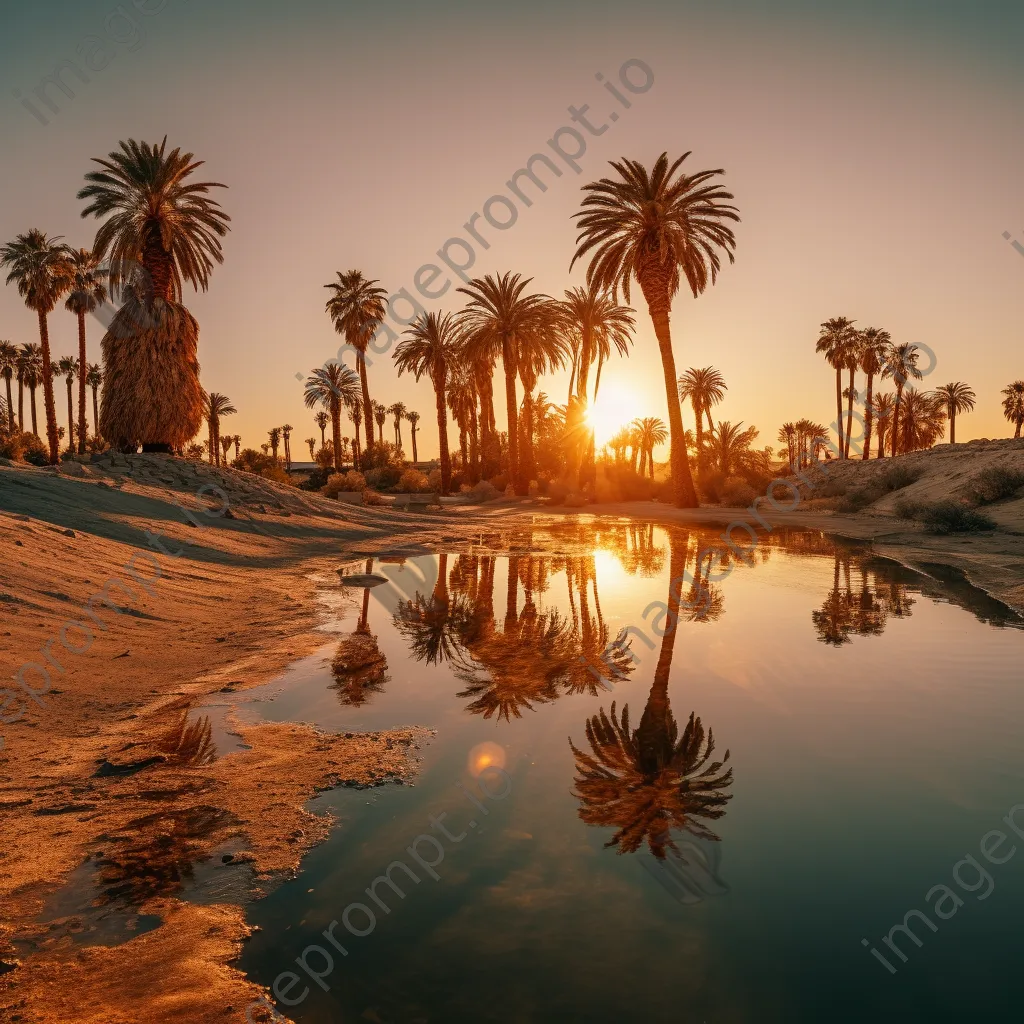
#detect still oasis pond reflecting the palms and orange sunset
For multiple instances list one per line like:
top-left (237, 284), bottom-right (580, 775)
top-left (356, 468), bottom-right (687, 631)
top-left (232, 521), bottom-right (1024, 1024)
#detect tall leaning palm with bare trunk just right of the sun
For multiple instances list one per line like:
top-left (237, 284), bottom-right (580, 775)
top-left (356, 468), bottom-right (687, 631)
top-left (570, 153), bottom-right (739, 508)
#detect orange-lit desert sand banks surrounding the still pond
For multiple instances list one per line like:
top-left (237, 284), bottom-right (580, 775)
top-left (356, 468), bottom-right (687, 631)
top-left (0, 441), bottom-right (1024, 1024)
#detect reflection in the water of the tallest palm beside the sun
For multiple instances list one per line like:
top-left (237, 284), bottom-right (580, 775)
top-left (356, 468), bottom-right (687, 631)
top-left (569, 534), bottom-right (732, 860)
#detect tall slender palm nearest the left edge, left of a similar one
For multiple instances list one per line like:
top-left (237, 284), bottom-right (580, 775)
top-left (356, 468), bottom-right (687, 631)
top-left (0, 234), bottom-right (73, 465)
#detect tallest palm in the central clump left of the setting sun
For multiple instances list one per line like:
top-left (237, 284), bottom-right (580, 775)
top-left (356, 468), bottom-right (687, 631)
top-left (459, 273), bottom-right (564, 495)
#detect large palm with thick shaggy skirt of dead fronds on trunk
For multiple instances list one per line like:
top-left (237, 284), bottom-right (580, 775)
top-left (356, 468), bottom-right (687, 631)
top-left (78, 136), bottom-right (230, 452)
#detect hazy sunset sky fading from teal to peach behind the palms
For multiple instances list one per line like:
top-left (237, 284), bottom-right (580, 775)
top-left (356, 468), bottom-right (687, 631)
top-left (0, 0), bottom-right (1024, 459)
